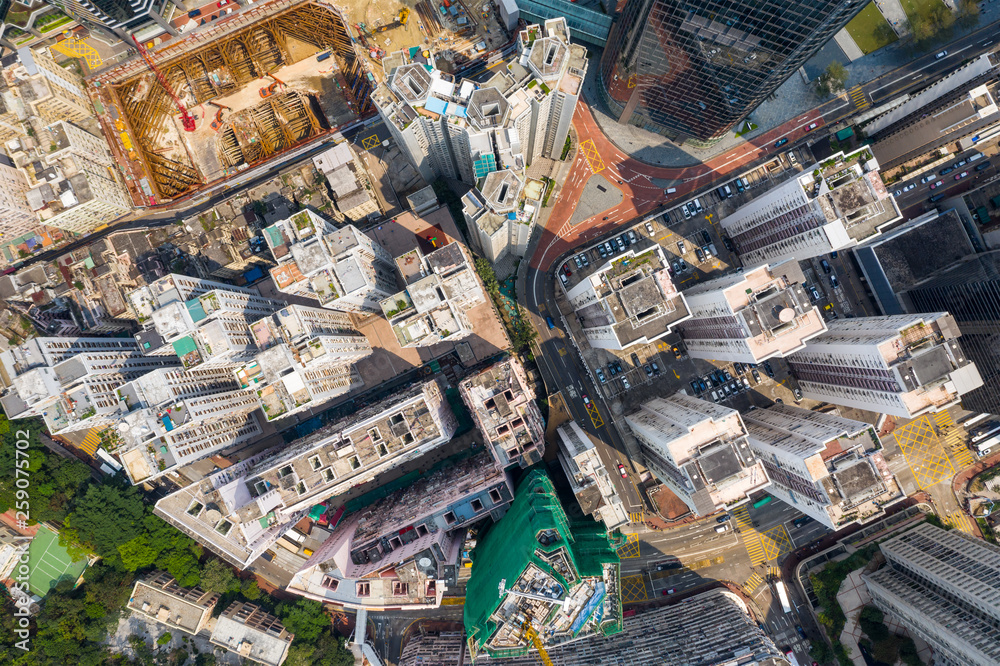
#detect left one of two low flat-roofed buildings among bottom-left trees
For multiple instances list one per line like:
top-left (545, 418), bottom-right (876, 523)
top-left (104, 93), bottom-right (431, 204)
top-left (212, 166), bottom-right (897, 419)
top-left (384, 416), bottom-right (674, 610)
top-left (126, 571), bottom-right (221, 636)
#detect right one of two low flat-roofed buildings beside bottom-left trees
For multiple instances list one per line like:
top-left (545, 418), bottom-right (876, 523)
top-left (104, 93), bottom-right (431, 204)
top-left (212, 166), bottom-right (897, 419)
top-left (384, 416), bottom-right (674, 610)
top-left (211, 601), bottom-right (295, 666)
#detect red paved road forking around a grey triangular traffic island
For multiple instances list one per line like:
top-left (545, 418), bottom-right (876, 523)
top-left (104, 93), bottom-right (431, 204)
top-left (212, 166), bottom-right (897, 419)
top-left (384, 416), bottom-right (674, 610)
top-left (531, 99), bottom-right (823, 271)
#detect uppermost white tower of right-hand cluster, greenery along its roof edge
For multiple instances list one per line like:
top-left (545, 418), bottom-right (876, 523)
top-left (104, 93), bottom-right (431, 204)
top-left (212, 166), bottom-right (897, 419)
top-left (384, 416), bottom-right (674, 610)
top-left (719, 147), bottom-right (902, 266)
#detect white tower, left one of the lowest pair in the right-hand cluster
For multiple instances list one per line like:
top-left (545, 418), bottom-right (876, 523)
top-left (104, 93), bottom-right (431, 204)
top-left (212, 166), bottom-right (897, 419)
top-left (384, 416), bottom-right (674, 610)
top-left (625, 393), bottom-right (771, 516)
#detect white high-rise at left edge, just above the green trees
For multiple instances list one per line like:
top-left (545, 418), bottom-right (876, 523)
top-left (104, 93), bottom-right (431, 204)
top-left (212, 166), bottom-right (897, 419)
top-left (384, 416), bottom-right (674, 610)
top-left (0, 338), bottom-right (179, 435)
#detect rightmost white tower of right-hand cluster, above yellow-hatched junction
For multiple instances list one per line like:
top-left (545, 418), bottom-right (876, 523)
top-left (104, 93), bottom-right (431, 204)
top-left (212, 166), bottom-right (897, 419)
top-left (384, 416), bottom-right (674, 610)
top-left (788, 312), bottom-right (983, 418)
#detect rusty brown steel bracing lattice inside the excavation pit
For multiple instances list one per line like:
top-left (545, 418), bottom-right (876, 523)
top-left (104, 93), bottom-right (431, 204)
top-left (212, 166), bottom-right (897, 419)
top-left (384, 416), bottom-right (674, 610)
top-left (92, 0), bottom-right (373, 200)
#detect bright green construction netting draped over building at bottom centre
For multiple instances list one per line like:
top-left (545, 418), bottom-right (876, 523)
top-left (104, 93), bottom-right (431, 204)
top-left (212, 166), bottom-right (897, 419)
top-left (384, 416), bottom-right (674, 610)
top-left (465, 469), bottom-right (621, 656)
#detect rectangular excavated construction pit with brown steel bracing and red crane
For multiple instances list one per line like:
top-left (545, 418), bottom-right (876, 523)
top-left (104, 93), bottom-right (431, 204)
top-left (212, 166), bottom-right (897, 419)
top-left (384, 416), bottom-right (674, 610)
top-left (89, 0), bottom-right (372, 206)
